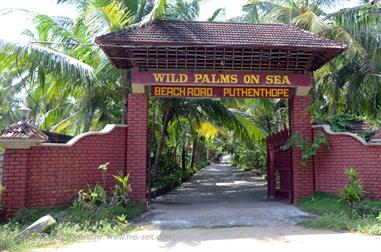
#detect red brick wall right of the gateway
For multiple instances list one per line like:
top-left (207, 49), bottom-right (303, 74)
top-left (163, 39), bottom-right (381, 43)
top-left (314, 128), bottom-right (381, 199)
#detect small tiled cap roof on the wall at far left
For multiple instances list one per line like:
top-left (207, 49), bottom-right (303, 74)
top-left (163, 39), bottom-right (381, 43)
top-left (0, 122), bottom-right (48, 141)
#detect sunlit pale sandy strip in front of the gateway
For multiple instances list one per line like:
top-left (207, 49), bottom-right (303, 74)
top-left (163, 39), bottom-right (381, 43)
top-left (38, 226), bottom-right (381, 252)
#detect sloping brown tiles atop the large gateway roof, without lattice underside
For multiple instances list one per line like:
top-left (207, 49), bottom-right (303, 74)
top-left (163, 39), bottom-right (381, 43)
top-left (96, 20), bottom-right (346, 49)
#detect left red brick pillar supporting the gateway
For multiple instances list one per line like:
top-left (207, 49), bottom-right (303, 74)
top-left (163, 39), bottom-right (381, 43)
top-left (127, 94), bottom-right (148, 201)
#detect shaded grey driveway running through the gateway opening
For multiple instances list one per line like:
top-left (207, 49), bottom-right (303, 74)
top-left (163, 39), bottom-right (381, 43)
top-left (138, 164), bottom-right (310, 228)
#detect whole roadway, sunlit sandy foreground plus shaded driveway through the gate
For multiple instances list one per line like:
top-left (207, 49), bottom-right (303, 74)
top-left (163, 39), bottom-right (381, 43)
top-left (38, 165), bottom-right (381, 252)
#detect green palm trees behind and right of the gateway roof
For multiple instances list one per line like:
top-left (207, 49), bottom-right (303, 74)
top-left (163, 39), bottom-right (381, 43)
top-left (235, 0), bottom-right (381, 118)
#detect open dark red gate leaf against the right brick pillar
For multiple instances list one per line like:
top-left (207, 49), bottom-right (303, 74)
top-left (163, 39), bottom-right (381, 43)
top-left (267, 130), bottom-right (292, 202)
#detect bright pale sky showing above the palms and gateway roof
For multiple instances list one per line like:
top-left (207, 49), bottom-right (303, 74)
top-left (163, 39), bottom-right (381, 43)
top-left (0, 0), bottom-right (359, 40)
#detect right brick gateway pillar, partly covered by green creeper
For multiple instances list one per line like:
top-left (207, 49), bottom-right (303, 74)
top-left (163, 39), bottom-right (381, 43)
top-left (289, 96), bottom-right (314, 202)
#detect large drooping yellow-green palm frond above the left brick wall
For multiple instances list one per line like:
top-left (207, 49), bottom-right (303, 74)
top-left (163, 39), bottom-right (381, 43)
top-left (0, 36), bottom-right (93, 132)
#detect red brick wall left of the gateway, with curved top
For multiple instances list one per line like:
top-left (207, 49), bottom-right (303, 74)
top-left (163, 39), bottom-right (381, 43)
top-left (2, 126), bottom-right (127, 216)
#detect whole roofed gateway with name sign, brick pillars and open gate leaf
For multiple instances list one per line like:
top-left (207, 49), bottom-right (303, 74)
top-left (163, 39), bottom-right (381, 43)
top-left (96, 21), bottom-right (346, 202)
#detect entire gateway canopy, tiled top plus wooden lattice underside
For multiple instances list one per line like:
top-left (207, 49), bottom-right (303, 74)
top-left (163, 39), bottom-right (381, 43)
top-left (95, 20), bottom-right (346, 73)
